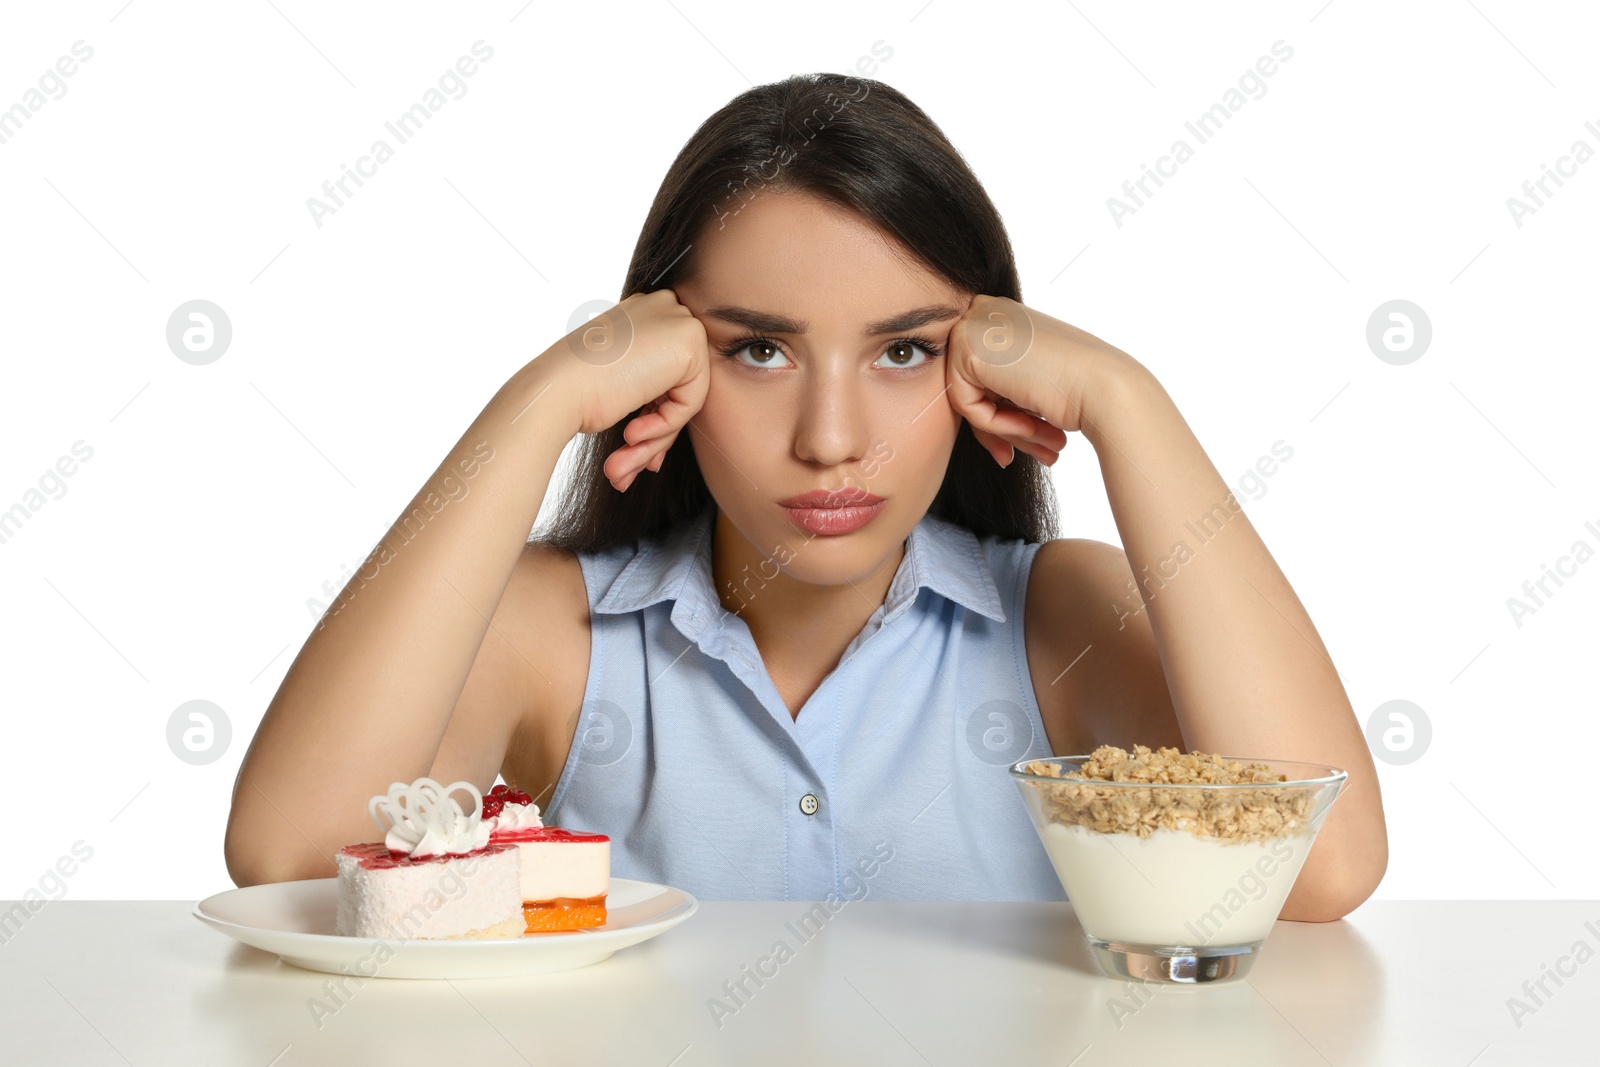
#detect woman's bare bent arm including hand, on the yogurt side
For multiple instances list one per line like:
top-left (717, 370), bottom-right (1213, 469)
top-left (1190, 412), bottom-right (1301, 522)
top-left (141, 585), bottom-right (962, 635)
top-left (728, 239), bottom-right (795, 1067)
top-left (946, 294), bottom-right (1389, 921)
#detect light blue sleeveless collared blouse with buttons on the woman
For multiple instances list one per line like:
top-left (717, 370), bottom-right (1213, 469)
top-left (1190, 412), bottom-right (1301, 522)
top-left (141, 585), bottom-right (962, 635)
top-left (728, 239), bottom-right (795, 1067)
top-left (546, 506), bottom-right (1067, 901)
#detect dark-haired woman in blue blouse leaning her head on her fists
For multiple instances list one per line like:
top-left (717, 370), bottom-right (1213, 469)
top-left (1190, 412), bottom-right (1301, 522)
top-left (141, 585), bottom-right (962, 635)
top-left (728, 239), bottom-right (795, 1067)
top-left (226, 75), bottom-right (1387, 920)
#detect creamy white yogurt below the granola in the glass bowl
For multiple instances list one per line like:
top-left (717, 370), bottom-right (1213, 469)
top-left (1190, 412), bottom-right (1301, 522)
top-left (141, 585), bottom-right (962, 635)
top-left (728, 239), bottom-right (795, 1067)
top-left (1040, 822), bottom-right (1314, 949)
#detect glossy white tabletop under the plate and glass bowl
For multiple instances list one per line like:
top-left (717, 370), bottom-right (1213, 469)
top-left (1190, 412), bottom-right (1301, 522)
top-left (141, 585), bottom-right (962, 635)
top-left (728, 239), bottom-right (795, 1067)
top-left (0, 899), bottom-right (1600, 1067)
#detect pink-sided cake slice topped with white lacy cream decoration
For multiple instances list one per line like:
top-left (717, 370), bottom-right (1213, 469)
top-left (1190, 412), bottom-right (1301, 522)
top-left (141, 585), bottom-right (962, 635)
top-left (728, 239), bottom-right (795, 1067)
top-left (334, 777), bottom-right (526, 939)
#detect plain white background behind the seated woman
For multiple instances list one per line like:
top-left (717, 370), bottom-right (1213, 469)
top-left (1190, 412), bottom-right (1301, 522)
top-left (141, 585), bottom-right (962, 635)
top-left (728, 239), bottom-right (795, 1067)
top-left (0, 0), bottom-right (1600, 899)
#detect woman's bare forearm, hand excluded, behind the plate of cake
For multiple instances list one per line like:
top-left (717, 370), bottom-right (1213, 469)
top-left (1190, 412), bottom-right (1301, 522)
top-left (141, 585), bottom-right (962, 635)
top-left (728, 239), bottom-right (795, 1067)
top-left (224, 349), bottom-right (578, 886)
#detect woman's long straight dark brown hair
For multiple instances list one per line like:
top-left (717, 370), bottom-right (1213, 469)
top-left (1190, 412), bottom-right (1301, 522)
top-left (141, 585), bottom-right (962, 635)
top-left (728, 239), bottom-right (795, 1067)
top-left (534, 74), bottom-right (1056, 553)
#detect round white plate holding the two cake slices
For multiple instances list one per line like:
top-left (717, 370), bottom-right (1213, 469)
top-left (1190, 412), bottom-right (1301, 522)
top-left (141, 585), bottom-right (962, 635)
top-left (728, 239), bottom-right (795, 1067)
top-left (194, 878), bottom-right (699, 979)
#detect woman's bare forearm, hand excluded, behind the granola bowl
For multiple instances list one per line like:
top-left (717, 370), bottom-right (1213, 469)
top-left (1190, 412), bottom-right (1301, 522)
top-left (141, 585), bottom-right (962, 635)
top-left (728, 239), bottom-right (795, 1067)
top-left (1080, 350), bottom-right (1389, 921)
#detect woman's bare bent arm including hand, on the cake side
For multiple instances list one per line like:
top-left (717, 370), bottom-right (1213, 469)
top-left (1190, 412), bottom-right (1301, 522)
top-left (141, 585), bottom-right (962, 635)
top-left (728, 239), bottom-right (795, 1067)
top-left (224, 290), bottom-right (710, 886)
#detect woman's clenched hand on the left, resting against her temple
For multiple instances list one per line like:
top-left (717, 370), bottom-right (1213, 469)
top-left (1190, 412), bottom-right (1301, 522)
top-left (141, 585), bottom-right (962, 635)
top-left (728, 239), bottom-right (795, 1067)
top-left (552, 290), bottom-right (710, 490)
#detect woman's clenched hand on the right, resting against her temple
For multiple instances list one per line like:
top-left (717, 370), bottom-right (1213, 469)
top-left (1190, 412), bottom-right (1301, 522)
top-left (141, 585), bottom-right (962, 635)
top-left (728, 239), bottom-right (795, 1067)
top-left (944, 294), bottom-right (1133, 467)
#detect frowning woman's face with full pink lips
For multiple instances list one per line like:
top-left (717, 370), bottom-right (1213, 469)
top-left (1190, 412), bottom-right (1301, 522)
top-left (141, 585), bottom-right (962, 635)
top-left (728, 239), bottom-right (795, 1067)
top-left (674, 192), bottom-right (971, 584)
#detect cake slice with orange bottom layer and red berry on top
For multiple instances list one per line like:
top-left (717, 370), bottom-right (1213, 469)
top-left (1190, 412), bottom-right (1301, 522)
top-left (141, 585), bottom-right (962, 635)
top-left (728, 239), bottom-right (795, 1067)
top-left (483, 784), bottom-right (611, 933)
